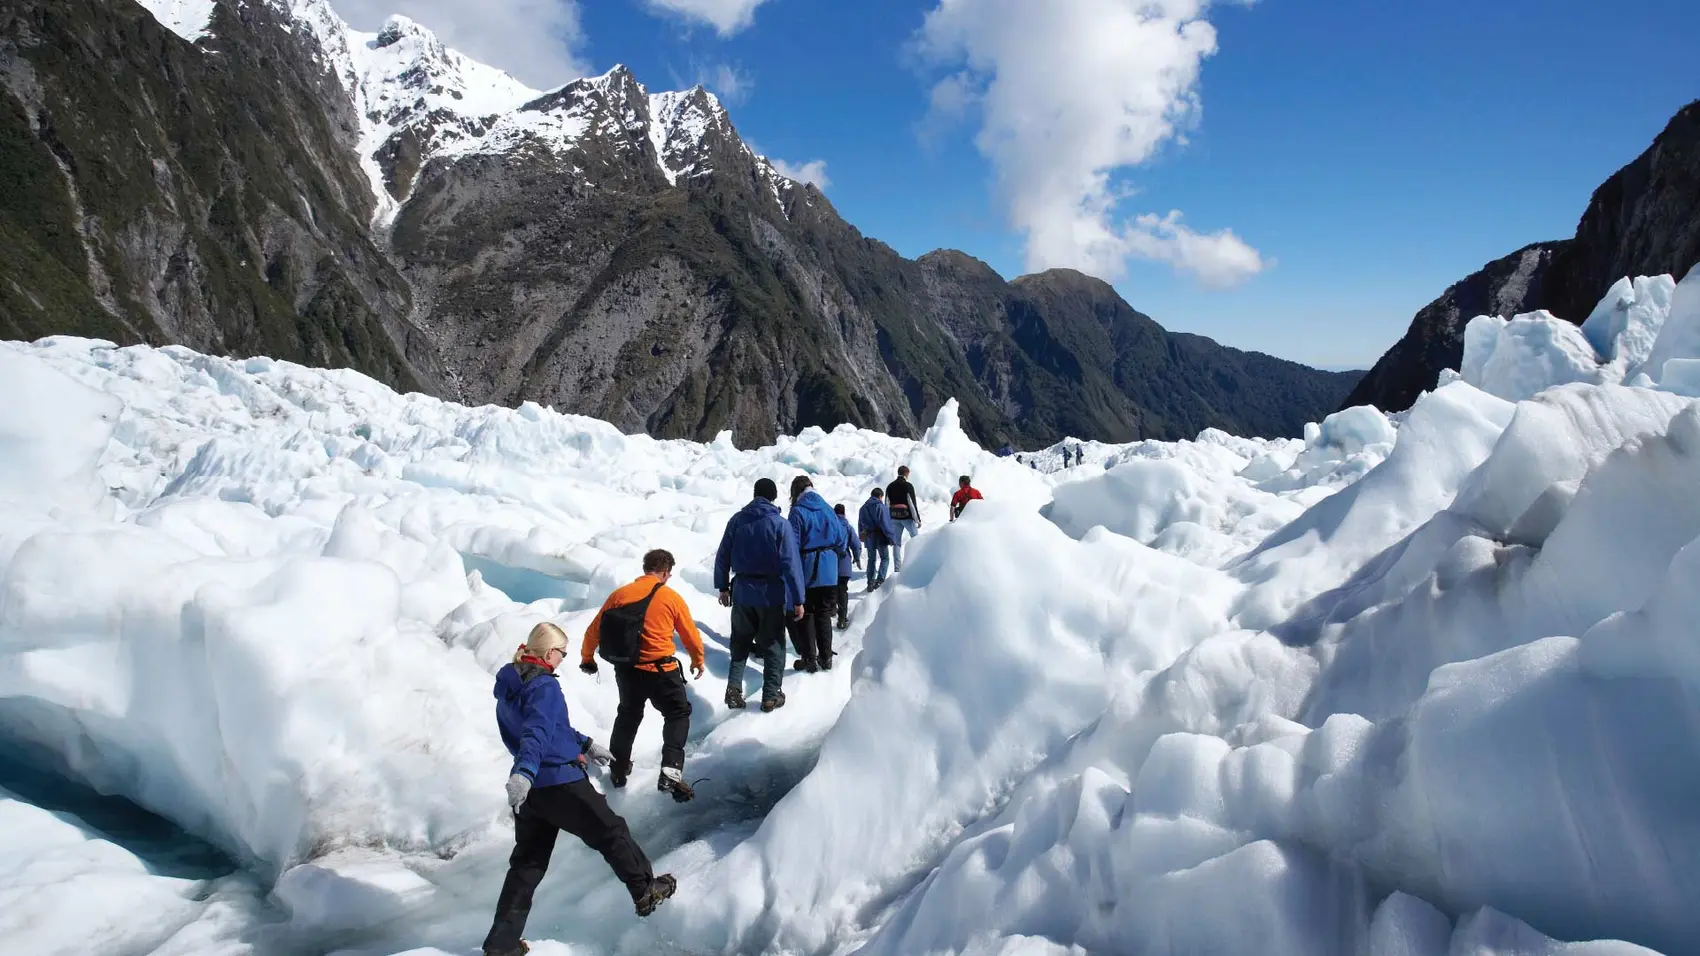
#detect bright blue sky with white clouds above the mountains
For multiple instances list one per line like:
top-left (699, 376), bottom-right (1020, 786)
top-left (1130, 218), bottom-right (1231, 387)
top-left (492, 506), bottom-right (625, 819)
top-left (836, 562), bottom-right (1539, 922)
top-left (338, 0), bottom-right (1700, 367)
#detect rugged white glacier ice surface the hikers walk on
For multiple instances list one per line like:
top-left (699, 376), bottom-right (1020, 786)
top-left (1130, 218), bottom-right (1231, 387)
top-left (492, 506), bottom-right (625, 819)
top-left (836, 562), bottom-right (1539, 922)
top-left (0, 268), bottom-right (1700, 956)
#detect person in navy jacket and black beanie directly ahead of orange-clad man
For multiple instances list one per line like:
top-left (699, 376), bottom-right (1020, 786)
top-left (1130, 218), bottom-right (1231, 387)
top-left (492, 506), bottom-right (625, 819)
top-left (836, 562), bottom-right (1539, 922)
top-left (714, 478), bottom-right (804, 713)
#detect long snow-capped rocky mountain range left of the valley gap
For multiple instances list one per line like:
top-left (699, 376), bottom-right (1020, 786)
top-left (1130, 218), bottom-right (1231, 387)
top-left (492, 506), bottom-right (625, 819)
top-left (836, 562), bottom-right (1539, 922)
top-left (0, 0), bottom-right (1353, 446)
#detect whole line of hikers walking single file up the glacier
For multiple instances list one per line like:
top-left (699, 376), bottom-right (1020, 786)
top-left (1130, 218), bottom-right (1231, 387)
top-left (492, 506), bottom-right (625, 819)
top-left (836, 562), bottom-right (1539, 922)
top-left (485, 466), bottom-right (981, 956)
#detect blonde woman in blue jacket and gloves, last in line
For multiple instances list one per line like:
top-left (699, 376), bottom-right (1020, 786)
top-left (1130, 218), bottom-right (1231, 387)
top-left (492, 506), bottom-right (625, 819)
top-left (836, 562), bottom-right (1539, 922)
top-left (485, 621), bottom-right (678, 956)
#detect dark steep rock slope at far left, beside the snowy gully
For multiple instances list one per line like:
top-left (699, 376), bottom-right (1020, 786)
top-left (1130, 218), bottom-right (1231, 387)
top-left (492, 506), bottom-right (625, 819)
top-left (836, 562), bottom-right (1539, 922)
top-left (0, 0), bottom-right (434, 388)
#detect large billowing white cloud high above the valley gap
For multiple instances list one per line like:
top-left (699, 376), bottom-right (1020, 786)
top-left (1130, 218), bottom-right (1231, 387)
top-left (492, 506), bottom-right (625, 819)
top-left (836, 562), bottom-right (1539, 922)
top-left (918, 0), bottom-right (1268, 286)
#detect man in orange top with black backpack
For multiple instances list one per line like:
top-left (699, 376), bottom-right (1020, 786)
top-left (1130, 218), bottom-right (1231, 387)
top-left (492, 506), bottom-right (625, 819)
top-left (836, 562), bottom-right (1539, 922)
top-left (578, 551), bottom-right (702, 803)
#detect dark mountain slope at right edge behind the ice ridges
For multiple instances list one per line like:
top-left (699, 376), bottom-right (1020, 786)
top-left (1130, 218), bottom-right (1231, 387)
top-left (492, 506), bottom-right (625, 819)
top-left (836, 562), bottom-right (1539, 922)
top-left (1343, 100), bottom-right (1700, 412)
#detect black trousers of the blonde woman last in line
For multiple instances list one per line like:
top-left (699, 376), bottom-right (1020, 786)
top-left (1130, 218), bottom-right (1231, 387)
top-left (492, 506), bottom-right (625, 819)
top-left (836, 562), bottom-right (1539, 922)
top-left (485, 781), bottom-right (655, 953)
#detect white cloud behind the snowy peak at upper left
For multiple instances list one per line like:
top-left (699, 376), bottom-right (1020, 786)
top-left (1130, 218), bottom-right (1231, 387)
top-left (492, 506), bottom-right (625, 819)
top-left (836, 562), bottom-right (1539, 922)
top-left (332, 0), bottom-right (592, 90)
